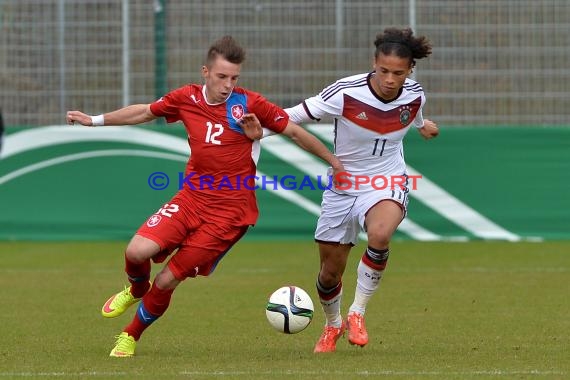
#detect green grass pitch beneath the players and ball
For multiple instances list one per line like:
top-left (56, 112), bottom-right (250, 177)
top-left (0, 242), bottom-right (570, 379)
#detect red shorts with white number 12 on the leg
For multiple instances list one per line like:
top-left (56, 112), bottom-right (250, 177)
top-left (137, 193), bottom-right (249, 281)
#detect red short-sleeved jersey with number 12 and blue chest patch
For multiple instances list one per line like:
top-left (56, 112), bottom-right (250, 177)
top-left (150, 84), bottom-right (289, 225)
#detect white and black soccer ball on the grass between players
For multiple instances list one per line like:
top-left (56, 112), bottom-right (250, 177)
top-left (265, 286), bottom-right (315, 334)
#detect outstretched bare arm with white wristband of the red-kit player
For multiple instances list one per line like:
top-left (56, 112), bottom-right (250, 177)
top-left (66, 104), bottom-right (157, 127)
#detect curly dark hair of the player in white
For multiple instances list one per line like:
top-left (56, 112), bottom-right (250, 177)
top-left (374, 28), bottom-right (431, 67)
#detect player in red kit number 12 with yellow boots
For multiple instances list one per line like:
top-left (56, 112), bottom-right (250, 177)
top-left (67, 36), bottom-right (344, 357)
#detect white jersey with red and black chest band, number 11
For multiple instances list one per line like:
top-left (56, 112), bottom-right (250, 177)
top-left (285, 73), bottom-right (426, 194)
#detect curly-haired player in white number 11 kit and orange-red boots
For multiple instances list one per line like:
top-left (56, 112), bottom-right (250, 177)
top-left (286, 28), bottom-right (438, 352)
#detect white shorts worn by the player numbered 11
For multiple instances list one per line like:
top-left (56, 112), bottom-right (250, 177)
top-left (315, 189), bottom-right (409, 245)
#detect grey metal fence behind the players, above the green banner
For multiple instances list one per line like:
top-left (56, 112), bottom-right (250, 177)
top-left (0, 0), bottom-right (570, 126)
